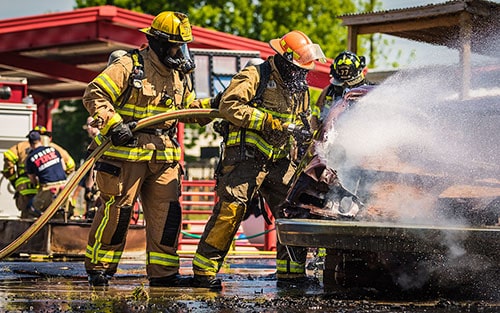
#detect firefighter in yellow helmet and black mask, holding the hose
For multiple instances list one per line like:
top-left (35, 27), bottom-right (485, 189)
top-left (83, 11), bottom-right (210, 286)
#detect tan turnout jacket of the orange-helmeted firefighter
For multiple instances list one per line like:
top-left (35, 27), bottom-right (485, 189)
top-left (219, 57), bottom-right (309, 159)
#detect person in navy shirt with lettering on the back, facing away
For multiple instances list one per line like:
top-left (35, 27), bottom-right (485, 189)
top-left (26, 130), bottom-right (71, 218)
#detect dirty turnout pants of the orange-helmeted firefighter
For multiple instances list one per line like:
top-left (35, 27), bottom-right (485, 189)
top-left (193, 147), bottom-right (307, 278)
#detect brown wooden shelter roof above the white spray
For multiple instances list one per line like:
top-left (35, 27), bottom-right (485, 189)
top-left (339, 0), bottom-right (500, 56)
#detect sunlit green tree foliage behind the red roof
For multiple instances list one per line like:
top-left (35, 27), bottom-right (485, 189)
top-left (76, 0), bottom-right (380, 59)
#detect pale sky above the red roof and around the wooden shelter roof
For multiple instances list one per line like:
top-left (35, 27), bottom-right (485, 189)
top-left (0, 0), bottom-right (500, 70)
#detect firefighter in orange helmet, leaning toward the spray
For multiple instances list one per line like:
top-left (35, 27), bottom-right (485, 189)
top-left (192, 30), bottom-right (325, 290)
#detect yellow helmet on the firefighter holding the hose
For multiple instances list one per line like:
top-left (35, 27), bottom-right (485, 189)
top-left (140, 11), bottom-right (193, 43)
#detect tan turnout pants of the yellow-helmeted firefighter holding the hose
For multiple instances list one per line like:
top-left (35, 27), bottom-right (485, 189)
top-left (85, 161), bottom-right (182, 278)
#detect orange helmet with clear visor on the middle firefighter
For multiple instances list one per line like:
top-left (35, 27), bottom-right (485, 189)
top-left (269, 30), bottom-right (326, 70)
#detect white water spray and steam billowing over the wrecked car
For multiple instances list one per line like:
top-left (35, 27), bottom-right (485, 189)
top-left (317, 48), bottom-right (500, 288)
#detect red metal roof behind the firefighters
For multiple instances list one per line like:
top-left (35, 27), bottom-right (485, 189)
top-left (0, 6), bottom-right (329, 99)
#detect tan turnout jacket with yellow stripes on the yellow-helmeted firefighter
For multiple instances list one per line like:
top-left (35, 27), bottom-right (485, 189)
top-left (83, 48), bottom-right (209, 163)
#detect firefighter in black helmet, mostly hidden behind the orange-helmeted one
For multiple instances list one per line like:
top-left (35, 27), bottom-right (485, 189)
top-left (311, 51), bottom-right (372, 129)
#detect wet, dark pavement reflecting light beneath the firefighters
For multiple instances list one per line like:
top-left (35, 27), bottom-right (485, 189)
top-left (0, 256), bottom-right (500, 313)
